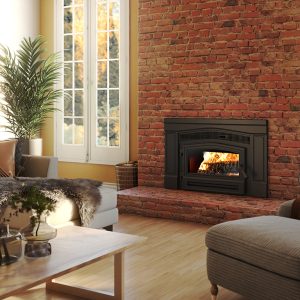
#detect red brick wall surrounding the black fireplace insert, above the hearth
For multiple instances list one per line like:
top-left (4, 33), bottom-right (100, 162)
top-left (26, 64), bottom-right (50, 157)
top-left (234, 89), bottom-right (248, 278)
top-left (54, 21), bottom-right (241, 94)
top-left (138, 0), bottom-right (300, 198)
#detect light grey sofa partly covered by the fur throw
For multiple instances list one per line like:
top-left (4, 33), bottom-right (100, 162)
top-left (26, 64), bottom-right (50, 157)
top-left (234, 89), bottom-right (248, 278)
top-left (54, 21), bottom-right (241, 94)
top-left (0, 155), bottom-right (118, 230)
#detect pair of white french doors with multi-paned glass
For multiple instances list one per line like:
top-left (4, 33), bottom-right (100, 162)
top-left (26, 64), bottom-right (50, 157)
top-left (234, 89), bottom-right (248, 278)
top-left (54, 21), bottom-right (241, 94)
top-left (56, 0), bottom-right (129, 164)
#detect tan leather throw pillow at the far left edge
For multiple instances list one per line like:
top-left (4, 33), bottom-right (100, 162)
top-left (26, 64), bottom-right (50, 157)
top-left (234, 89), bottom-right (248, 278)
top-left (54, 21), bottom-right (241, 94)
top-left (0, 140), bottom-right (17, 177)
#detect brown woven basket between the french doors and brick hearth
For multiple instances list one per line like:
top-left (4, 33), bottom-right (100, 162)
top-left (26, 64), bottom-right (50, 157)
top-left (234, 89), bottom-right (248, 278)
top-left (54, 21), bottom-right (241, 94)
top-left (115, 161), bottom-right (138, 191)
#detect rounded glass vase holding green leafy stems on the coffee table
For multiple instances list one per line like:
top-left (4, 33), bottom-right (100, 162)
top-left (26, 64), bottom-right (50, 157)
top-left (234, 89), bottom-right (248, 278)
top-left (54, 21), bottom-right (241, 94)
top-left (20, 216), bottom-right (57, 257)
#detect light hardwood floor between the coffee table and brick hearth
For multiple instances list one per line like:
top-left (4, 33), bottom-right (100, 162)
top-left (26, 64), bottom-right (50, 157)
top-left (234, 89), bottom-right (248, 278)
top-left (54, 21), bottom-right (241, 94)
top-left (8, 215), bottom-right (245, 300)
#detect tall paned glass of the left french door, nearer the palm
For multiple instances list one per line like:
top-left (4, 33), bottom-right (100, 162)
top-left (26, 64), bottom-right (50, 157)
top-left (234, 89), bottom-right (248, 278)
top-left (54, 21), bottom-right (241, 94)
top-left (63, 0), bottom-right (85, 145)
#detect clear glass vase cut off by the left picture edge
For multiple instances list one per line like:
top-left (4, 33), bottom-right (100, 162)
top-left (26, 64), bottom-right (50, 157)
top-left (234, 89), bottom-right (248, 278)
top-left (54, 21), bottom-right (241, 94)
top-left (0, 226), bottom-right (22, 266)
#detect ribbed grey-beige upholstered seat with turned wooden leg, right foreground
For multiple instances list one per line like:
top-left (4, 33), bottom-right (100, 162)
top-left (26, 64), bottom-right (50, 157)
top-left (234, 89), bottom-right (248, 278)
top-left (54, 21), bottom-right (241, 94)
top-left (206, 201), bottom-right (300, 300)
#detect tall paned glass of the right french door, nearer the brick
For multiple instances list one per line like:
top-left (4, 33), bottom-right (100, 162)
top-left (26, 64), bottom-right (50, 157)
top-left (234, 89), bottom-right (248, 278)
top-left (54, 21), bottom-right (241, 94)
top-left (96, 0), bottom-right (120, 147)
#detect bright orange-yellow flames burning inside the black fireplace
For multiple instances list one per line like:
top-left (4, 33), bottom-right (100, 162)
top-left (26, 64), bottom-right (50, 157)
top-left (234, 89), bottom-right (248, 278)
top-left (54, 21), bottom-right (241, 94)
top-left (199, 152), bottom-right (239, 171)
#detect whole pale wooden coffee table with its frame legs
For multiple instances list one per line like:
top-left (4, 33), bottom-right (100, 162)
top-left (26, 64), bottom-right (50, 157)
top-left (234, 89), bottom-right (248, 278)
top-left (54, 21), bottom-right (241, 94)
top-left (0, 226), bottom-right (145, 300)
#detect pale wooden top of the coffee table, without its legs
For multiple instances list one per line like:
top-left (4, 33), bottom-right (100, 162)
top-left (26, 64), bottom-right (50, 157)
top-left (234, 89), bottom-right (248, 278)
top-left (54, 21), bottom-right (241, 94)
top-left (0, 226), bottom-right (145, 299)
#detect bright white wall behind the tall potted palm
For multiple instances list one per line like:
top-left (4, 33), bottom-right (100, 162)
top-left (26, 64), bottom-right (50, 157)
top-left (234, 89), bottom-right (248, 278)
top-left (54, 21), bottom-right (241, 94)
top-left (0, 0), bottom-right (39, 140)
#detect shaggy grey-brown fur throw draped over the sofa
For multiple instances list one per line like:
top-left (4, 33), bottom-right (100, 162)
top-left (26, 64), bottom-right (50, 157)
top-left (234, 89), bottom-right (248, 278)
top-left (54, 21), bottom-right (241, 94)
top-left (0, 177), bottom-right (102, 226)
